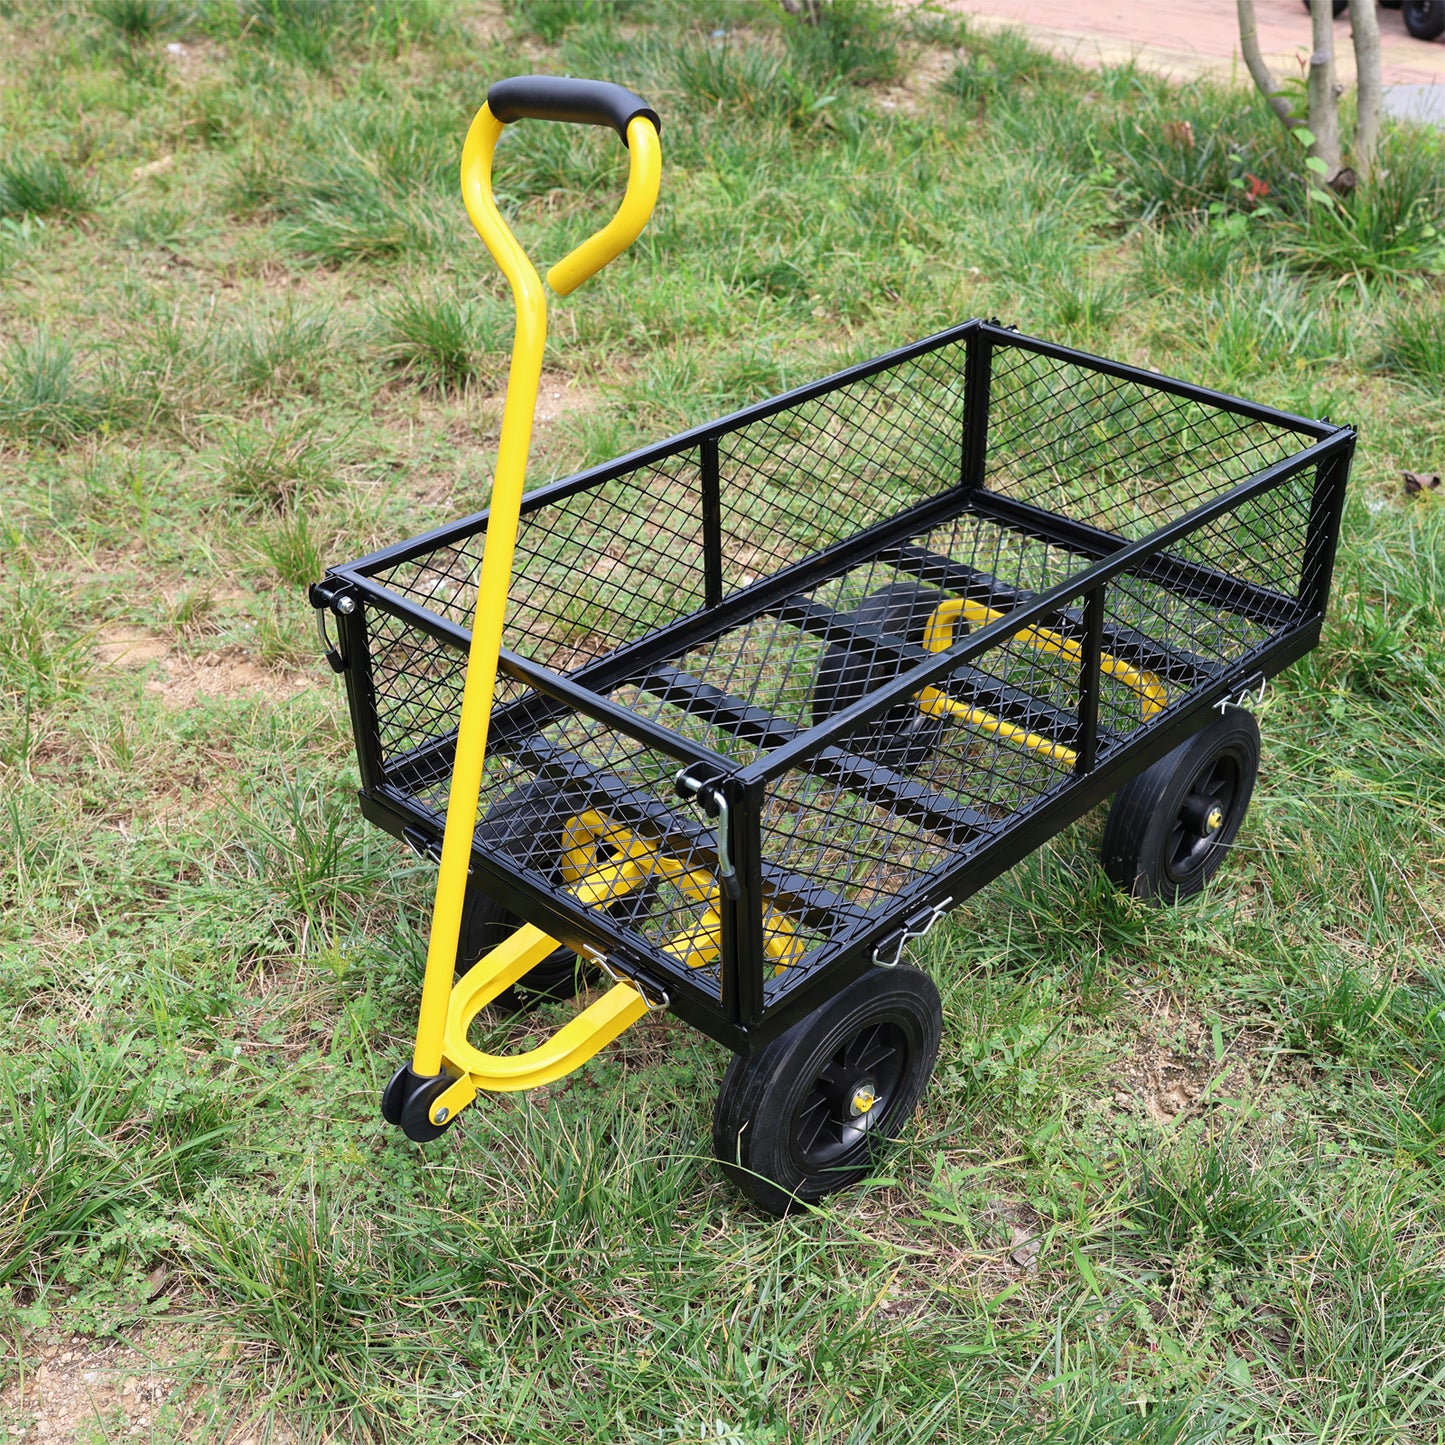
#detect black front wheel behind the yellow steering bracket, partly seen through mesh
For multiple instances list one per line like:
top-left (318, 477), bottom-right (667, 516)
top-left (457, 783), bottom-right (656, 1013)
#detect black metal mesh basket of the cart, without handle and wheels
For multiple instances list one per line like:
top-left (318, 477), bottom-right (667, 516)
top-left (312, 321), bottom-right (1355, 1053)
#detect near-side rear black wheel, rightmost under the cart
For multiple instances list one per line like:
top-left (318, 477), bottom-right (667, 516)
top-left (1101, 708), bottom-right (1260, 903)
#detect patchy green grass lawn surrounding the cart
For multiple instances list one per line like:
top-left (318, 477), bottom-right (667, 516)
top-left (0, 0), bottom-right (1445, 1445)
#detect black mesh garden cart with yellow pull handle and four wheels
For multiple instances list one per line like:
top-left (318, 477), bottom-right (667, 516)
top-left (311, 77), bottom-right (1354, 1211)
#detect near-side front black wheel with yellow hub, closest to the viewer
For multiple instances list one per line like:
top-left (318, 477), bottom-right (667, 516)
top-left (712, 965), bottom-right (942, 1214)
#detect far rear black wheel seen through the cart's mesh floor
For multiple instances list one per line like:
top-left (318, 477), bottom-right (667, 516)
top-left (812, 582), bottom-right (968, 769)
